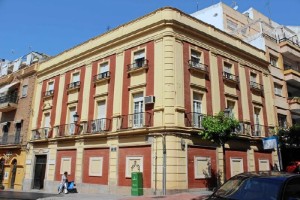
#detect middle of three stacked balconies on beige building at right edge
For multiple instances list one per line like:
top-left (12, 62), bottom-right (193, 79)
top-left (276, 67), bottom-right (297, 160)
top-left (284, 65), bottom-right (300, 88)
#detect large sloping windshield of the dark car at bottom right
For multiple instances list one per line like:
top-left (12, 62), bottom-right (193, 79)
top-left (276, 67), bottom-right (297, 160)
top-left (214, 177), bottom-right (283, 200)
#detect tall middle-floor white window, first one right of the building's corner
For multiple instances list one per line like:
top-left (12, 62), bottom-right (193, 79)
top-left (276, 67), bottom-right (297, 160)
top-left (193, 92), bottom-right (203, 128)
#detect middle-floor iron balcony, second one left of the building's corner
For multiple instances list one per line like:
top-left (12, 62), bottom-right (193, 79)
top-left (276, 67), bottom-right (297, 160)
top-left (86, 118), bottom-right (111, 134)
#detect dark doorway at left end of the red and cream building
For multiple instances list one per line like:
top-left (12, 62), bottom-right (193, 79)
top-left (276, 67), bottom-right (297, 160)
top-left (33, 155), bottom-right (47, 189)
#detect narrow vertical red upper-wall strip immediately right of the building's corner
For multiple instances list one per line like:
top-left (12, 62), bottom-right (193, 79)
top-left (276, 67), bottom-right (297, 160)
top-left (183, 42), bottom-right (192, 113)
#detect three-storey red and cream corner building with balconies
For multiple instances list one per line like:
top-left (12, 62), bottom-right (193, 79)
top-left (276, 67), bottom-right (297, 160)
top-left (24, 8), bottom-right (278, 194)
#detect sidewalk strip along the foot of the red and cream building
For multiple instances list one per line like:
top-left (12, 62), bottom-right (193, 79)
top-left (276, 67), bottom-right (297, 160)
top-left (40, 191), bottom-right (211, 200)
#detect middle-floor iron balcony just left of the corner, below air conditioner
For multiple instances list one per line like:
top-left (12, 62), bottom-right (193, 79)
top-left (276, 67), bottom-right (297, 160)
top-left (117, 112), bottom-right (152, 130)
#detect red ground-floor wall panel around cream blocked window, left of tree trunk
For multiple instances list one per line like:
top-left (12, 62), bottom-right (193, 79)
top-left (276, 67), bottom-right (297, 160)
top-left (188, 146), bottom-right (217, 188)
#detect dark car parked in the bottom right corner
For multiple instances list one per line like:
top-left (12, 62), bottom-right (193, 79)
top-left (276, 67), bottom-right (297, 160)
top-left (205, 172), bottom-right (300, 200)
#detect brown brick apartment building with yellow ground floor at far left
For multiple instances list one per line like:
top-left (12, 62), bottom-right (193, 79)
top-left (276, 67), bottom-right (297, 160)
top-left (0, 52), bottom-right (46, 190)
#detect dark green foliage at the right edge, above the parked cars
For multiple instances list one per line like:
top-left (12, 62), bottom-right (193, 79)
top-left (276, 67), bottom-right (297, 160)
top-left (278, 124), bottom-right (300, 147)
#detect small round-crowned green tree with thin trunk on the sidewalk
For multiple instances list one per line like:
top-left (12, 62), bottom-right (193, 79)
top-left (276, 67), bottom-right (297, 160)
top-left (199, 112), bottom-right (239, 184)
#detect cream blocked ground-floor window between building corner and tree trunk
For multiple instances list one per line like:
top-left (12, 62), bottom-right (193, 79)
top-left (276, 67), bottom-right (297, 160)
top-left (194, 156), bottom-right (211, 179)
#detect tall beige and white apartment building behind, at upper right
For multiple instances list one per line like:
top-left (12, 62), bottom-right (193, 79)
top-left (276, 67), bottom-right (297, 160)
top-left (192, 3), bottom-right (300, 128)
